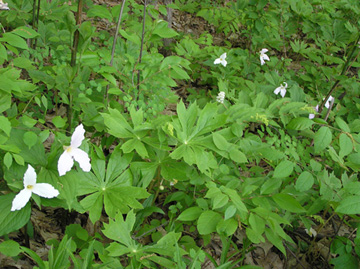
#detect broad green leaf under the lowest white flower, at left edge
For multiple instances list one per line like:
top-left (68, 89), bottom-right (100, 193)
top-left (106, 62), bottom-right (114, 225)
top-left (0, 193), bottom-right (31, 236)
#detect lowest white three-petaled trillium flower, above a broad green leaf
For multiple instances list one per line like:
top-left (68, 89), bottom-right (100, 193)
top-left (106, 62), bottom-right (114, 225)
top-left (11, 164), bottom-right (59, 211)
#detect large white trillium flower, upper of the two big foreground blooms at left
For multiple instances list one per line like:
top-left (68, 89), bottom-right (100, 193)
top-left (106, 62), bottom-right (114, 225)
top-left (58, 124), bottom-right (91, 176)
